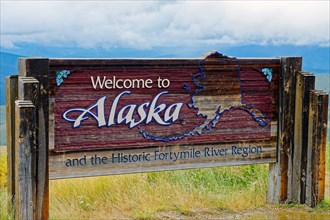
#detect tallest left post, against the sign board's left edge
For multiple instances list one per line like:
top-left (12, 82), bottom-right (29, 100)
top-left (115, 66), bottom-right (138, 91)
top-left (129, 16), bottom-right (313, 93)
top-left (18, 58), bottom-right (49, 219)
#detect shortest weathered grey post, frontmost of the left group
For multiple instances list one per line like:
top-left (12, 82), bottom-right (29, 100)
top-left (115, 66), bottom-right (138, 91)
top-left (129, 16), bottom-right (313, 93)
top-left (15, 100), bottom-right (36, 219)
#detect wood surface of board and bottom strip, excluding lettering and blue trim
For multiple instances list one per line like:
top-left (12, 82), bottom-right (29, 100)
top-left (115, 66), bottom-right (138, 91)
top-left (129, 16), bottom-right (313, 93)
top-left (49, 54), bottom-right (280, 178)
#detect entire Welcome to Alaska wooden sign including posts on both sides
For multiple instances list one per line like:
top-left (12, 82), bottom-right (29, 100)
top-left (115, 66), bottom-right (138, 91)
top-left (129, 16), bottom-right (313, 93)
top-left (6, 52), bottom-right (329, 219)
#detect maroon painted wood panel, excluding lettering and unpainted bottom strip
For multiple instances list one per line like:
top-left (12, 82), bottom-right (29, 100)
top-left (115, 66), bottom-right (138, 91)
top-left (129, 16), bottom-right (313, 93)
top-left (50, 57), bottom-right (279, 151)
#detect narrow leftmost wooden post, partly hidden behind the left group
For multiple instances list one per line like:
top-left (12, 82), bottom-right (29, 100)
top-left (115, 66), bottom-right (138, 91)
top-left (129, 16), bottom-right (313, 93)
top-left (6, 75), bottom-right (18, 216)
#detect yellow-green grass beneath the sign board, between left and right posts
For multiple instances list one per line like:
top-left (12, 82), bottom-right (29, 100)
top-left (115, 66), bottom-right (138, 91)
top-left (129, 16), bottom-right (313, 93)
top-left (50, 166), bottom-right (267, 219)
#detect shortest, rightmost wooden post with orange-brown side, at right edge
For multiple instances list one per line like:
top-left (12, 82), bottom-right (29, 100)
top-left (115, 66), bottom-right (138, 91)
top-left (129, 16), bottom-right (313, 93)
top-left (306, 91), bottom-right (329, 207)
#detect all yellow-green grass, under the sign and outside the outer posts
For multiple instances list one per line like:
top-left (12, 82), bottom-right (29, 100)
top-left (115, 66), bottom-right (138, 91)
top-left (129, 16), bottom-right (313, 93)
top-left (0, 144), bottom-right (330, 219)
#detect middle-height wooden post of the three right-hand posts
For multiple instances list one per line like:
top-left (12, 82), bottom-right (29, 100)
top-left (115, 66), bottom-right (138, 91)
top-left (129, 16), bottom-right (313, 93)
top-left (290, 73), bottom-right (315, 203)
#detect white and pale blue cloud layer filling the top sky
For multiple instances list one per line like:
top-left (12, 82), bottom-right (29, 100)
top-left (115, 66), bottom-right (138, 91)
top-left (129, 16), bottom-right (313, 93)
top-left (0, 1), bottom-right (330, 49)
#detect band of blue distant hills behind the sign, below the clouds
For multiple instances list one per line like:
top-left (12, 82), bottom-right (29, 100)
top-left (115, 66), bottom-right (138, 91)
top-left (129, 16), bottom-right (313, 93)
top-left (0, 44), bottom-right (330, 105)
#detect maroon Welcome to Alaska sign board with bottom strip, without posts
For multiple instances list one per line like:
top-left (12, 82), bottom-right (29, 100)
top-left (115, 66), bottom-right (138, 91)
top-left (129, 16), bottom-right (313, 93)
top-left (49, 52), bottom-right (280, 178)
